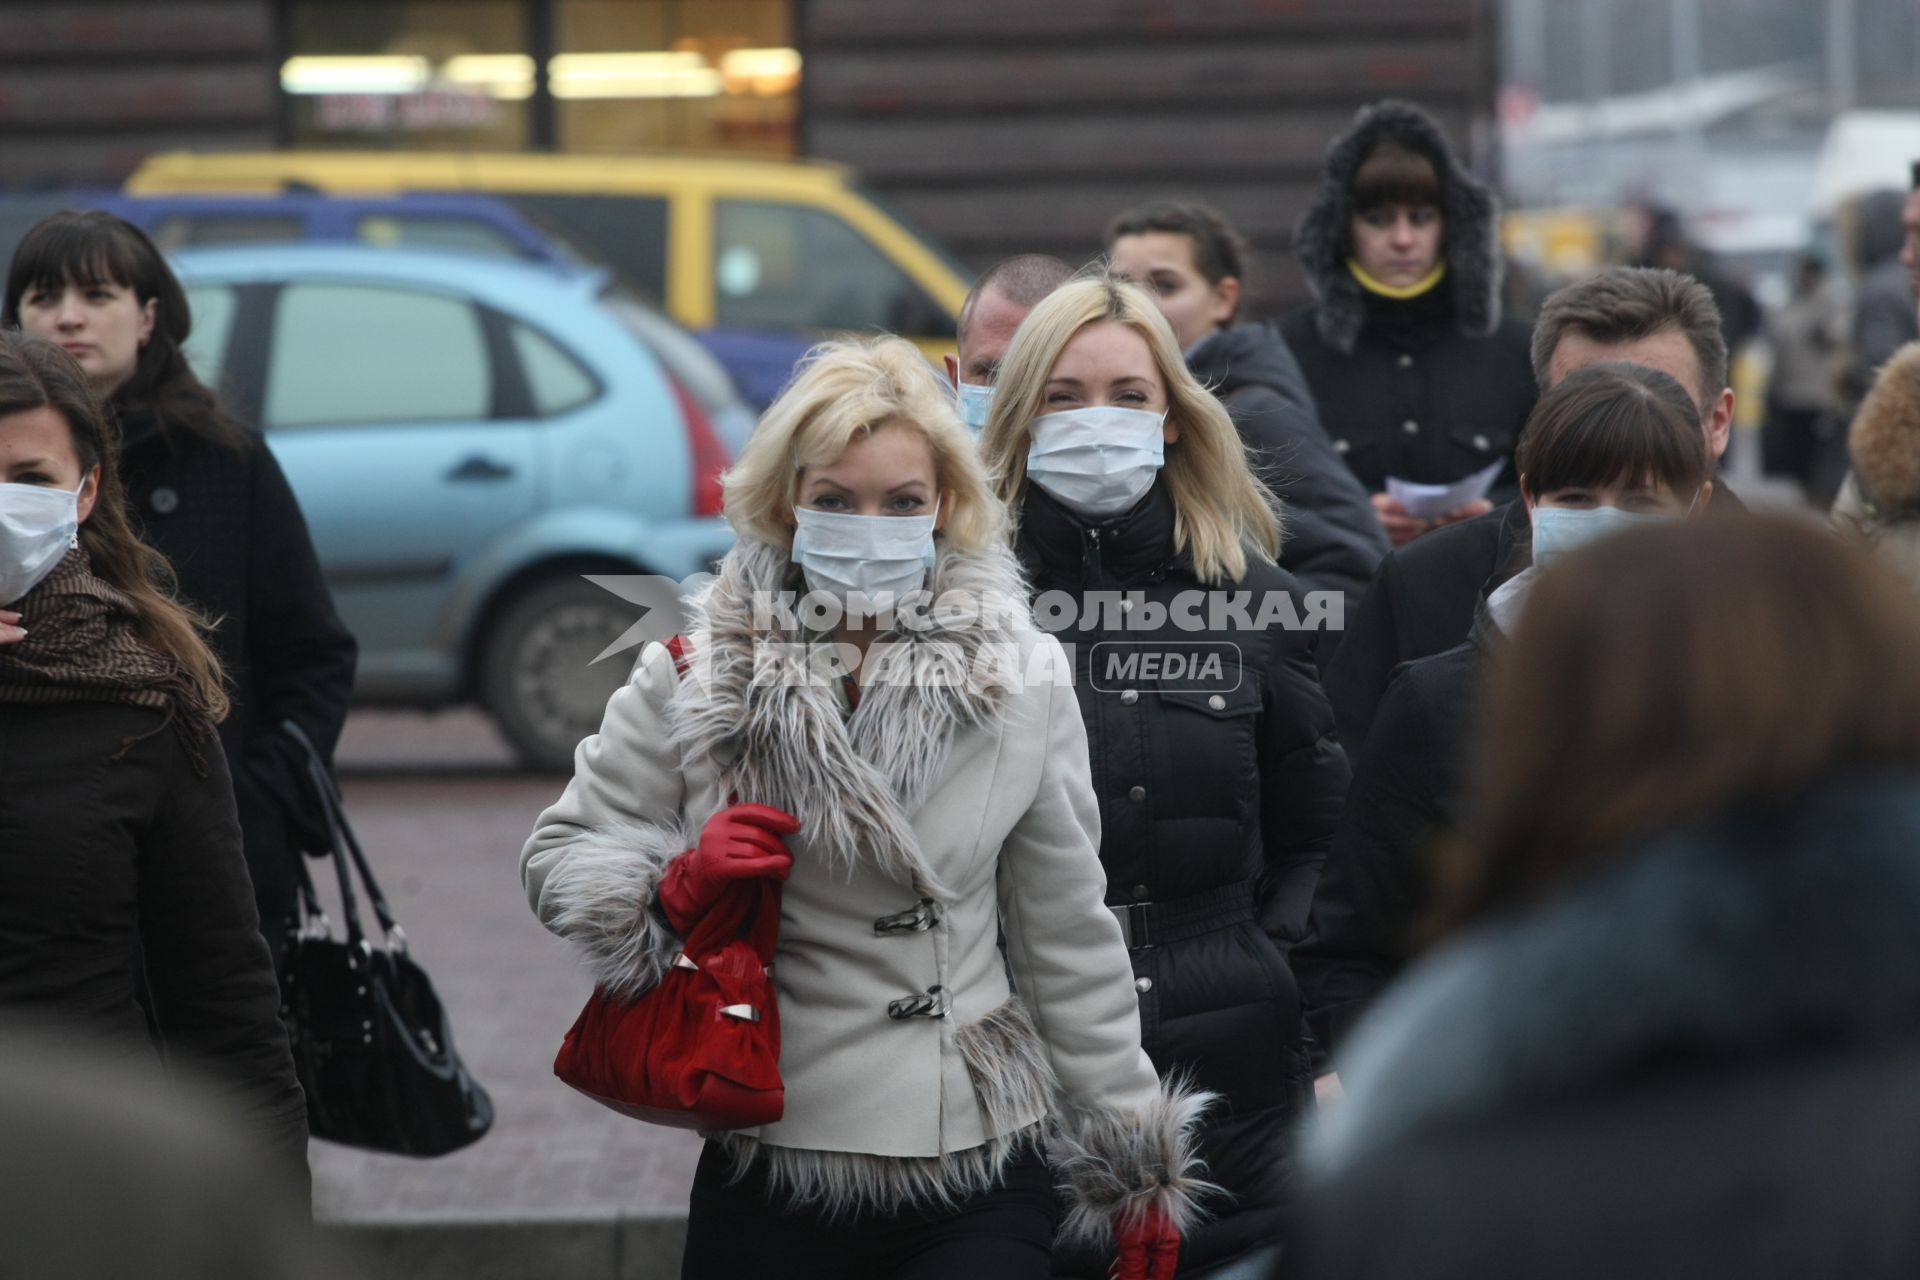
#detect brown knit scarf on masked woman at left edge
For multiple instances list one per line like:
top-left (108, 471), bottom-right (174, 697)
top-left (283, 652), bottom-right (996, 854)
top-left (0, 547), bottom-right (213, 775)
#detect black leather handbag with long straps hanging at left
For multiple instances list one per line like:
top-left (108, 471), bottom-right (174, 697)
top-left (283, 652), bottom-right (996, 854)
top-left (280, 722), bottom-right (493, 1155)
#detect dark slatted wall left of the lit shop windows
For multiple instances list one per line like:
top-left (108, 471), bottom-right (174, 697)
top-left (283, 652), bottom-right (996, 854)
top-left (0, 0), bottom-right (276, 190)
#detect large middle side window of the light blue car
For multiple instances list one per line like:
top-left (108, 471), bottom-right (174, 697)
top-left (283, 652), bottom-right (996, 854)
top-left (261, 282), bottom-right (493, 432)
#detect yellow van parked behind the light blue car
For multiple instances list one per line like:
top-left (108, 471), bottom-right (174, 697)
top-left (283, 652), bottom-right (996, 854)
top-left (127, 152), bottom-right (970, 368)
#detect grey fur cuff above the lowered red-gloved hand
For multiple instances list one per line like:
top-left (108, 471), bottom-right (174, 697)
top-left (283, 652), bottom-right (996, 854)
top-left (1046, 1080), bottom-right (1219, 1245)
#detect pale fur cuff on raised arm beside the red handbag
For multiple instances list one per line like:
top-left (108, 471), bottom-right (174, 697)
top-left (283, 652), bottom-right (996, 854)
top-left (541, 823), bottom-right (687, 998)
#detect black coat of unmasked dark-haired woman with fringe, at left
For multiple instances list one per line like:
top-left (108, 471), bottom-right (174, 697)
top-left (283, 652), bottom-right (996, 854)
top-left (121, 415), bottom-right (355, 954)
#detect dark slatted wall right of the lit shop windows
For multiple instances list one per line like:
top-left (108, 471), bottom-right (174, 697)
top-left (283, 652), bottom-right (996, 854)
top-left (799, 0), bottom-right (1496, 313)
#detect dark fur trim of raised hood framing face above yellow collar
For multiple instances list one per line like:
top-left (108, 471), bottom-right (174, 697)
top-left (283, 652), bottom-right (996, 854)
top-left (1294, 98), bottom-right (1505, 351)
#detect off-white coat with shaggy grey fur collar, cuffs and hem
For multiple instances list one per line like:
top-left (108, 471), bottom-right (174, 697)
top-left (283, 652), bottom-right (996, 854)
top-left (520, 539), bottom-right (1206, 1238)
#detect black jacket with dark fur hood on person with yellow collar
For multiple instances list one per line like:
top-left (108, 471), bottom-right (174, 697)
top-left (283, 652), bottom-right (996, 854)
top-left (1281, 102), bottom-right (1536, 503)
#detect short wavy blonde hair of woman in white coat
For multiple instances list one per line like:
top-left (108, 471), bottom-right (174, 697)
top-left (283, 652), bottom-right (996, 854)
top-left (720, 336), bottom-right (1004, 551)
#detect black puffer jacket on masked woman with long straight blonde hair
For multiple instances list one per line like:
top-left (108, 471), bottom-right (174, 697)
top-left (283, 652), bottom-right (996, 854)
top-left (1020, 484), bottom-right (1346, 1278)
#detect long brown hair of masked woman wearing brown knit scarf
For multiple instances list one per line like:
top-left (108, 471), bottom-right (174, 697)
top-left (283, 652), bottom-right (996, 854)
top-left (0, 330), bottom-right (227, 720)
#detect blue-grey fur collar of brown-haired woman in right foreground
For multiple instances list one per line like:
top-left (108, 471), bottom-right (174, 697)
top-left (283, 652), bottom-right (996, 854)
top-left (1308, 773), bottom-right (1920, 1174)
